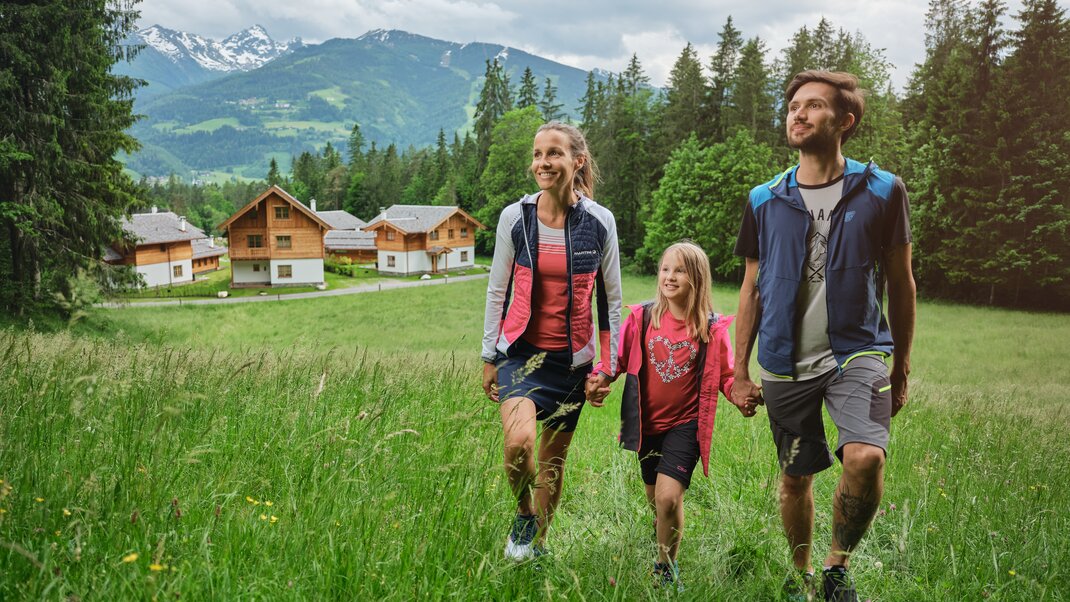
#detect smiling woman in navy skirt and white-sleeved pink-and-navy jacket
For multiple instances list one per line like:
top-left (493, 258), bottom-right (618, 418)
top-left (483, 122), bottom-right (621, 560)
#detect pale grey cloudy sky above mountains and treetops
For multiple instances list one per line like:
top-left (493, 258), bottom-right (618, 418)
top-left (133, 0), bottom-right (1035, 88)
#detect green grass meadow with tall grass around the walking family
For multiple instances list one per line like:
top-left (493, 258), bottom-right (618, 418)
top-left (0, 277), bottom-right (1070, 601)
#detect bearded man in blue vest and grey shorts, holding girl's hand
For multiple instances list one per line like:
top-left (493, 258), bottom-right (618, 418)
top-left (731, 71), bottom-right (915, 602)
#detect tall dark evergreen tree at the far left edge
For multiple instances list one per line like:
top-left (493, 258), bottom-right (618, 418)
top-left (0, 0), bottom-right (138, 313)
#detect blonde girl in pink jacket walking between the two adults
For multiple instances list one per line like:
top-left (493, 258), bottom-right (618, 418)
top-left (587, 242), bottom-right (754, 589)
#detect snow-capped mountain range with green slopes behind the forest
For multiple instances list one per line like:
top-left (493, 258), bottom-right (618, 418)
top-left (116, 26), bottom-right (605, 179)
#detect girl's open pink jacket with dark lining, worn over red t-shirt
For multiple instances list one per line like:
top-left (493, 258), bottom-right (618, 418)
top-left (593, 304), bottom-right (735, 477)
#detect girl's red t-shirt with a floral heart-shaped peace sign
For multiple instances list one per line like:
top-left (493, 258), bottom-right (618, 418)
top-left (639, 311), bottom-right (701, 435)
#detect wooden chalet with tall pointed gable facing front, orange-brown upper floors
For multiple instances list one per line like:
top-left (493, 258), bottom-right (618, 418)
top-left (218, 186), bottom-right (331, 288)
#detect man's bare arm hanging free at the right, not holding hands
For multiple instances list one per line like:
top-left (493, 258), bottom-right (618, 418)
top-left (881, 243), bottom-right (917, 416)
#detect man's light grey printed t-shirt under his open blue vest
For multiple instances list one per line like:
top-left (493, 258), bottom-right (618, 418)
top-left (762, 175), bottom-right (843, 381)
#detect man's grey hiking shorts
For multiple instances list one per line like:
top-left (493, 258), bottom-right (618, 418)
top-left (762, 355), bottom-right (891, 477)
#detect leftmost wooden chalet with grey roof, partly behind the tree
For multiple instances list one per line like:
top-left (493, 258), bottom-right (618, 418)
top-left (104, 207), bottom-right (208, 287)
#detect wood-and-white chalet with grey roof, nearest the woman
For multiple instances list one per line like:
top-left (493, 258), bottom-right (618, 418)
top-left (364, 205), bottom-right (486, 275)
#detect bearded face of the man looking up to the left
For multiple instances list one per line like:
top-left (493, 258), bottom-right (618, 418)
top-left (785, 81), bottom-right (852, 153)
